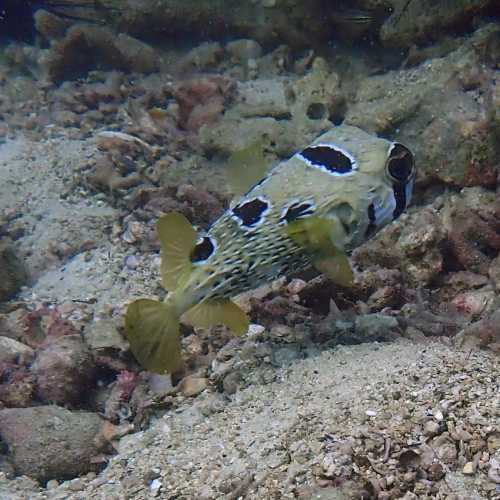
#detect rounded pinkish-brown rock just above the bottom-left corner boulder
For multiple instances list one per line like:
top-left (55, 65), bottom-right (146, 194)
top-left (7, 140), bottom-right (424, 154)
top-left (32, 335), bottom-right (95, 406)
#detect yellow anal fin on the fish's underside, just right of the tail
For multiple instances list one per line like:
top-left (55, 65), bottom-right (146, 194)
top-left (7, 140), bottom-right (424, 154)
top-left (183, 299), bottom-right (250, 335)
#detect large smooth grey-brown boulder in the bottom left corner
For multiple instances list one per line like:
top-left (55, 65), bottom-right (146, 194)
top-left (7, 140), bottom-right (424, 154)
top-left (0, 406), bottom-right (101, 481)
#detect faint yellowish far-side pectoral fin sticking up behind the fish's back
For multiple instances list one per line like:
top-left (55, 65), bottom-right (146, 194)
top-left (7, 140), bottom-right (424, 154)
top-left (226, 140), bottom-right (269, 197)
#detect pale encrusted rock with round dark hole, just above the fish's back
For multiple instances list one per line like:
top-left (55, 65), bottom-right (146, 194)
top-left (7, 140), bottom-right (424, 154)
top-left (199, 58), bottom-right (344, 157)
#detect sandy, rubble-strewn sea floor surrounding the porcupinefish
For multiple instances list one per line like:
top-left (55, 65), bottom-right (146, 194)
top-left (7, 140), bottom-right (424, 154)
top-left (0, 0), bottom-right (500, 500)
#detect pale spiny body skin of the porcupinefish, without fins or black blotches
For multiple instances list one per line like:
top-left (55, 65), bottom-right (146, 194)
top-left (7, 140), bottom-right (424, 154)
top-left (167, 126), bottom-right (414, 313)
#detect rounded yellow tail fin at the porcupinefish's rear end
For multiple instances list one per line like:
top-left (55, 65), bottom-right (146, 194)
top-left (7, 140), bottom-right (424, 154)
top-left (125, 299), bottom-right (182, 373)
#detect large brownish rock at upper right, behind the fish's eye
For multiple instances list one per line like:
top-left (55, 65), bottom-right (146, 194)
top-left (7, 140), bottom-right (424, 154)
top-left (346, 23), bottom-right (500, 187)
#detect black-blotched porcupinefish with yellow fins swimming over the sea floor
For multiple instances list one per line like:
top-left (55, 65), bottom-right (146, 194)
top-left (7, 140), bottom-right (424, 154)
top-left (125, 125), bottom-right (416, 372)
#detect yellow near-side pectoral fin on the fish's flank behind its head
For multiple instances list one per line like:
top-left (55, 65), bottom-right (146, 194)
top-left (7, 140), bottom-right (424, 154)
top-left (287, 217), bottom-right (354, 287)
